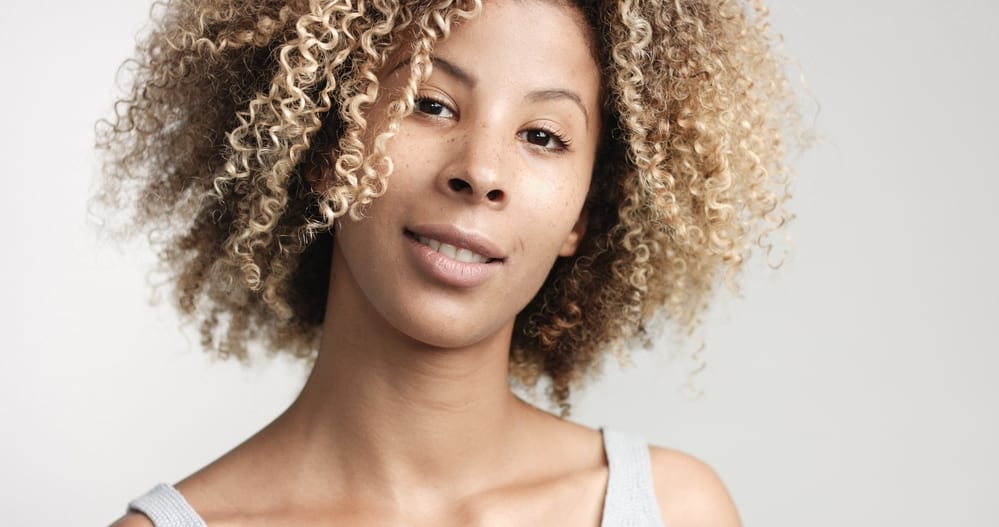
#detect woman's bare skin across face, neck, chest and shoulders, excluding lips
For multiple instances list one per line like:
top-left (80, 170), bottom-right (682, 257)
top-left (115, 0), bottom-right (739, 527)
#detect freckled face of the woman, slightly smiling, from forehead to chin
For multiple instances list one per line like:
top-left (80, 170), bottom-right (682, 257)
top-left (330, 0), bottom-right (601, 348)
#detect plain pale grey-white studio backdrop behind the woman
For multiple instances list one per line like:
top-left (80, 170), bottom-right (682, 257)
top-left (0, 0), bottom-right (999, 527)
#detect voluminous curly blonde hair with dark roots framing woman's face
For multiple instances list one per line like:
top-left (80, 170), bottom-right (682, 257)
top-left (98, 0), bottom-right (796, 412)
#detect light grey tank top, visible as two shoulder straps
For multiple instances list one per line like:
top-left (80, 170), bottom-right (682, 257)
top-left (128, 428), bottom-right (663, 527)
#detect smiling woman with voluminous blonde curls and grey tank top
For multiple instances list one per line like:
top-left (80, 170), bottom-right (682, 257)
top-left (100, 0), bottom-right (786, 527)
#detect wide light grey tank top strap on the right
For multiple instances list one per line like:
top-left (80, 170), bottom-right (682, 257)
top-left (600, 428), bottom-right (663, 527)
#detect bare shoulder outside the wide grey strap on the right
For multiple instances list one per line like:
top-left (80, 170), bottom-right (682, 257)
top-left (649, 447), bottom-right (742, 527)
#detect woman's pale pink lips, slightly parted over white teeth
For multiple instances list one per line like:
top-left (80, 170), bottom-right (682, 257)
top-left (403, 225), bottom-right (504, 288)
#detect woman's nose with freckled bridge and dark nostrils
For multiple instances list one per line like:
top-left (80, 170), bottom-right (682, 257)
top-left (438, 130), bottom-right (510, 209)
